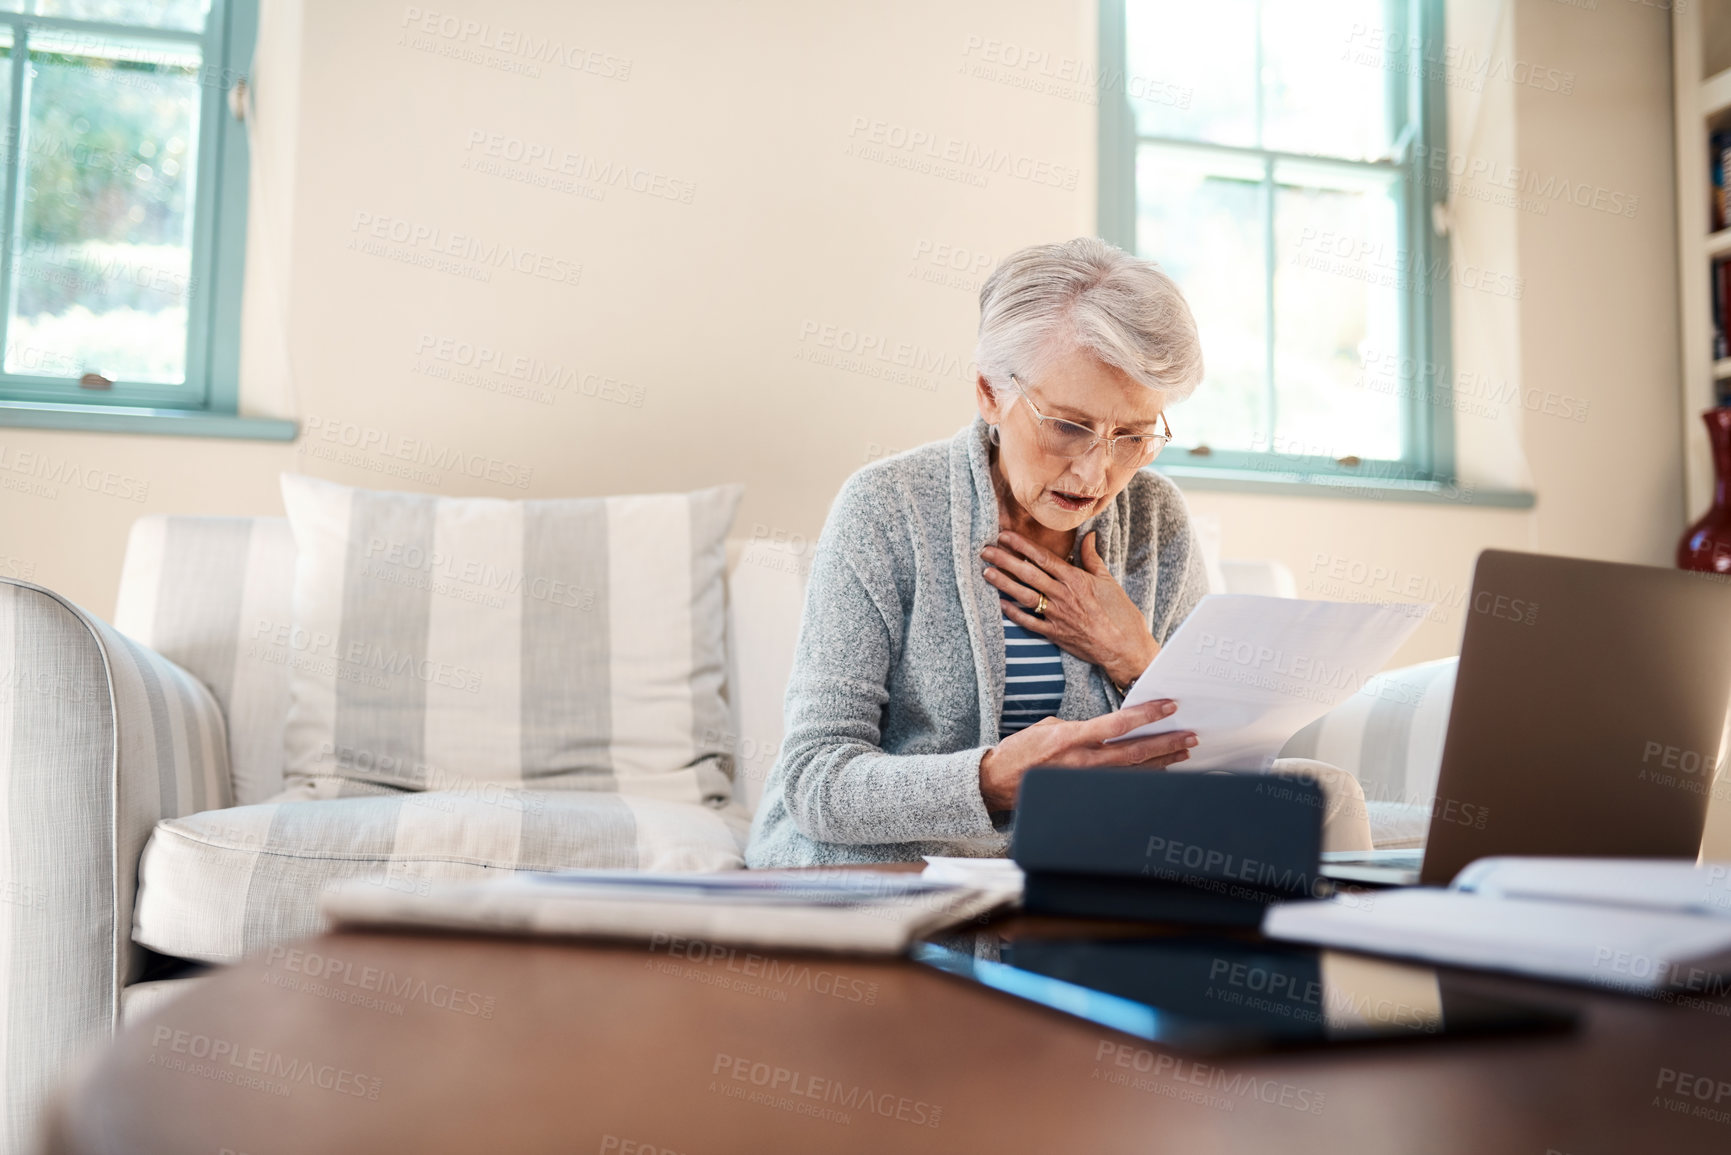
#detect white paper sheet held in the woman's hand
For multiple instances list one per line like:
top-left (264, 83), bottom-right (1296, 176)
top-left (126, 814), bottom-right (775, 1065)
top-left (1108, 594), bottom-right (1430, 771)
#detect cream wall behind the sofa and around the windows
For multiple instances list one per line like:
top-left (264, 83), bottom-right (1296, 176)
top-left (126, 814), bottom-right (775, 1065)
top-left (0, 0), bottom-right (1683, 671)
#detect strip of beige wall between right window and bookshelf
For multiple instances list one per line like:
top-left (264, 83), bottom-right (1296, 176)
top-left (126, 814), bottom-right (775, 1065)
top-left (1515, 0), bottom-right (1702, 565)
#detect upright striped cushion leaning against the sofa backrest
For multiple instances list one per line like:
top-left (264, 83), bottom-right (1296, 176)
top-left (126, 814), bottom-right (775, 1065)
top-left (272, 474), bottom-right (744, 802)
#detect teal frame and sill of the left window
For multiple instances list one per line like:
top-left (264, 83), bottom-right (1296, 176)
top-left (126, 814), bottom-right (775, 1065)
top-left (0, 0), bottom-right (296, 440)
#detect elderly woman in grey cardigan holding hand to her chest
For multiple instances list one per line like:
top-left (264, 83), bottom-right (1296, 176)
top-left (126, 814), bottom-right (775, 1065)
top-left (746, 237), bottom-right (1369, 868)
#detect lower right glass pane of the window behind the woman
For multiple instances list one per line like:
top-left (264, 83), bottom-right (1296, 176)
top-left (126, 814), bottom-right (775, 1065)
top-left (1264, 163), bottom-right (1405, 459)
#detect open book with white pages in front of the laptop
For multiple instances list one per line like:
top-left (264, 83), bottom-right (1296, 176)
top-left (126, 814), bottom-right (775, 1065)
top-left (1262, 857), bottom-right (1731, 996)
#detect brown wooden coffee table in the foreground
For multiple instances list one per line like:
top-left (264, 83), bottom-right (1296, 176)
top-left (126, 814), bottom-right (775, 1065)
top-left (50, 921), bottom-right (1731, 1155)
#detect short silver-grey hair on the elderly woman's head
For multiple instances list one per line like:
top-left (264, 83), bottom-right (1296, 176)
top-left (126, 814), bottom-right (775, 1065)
top-left (975, 237), bottom-right (1203, 402)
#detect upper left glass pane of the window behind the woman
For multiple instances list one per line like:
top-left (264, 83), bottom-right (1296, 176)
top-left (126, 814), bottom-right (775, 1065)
top-left (1125, 0), bottom-right (1257, 147)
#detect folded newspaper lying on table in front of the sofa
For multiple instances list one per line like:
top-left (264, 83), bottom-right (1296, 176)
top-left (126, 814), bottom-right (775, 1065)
top-left (320, 869), bottom-right (1014, 954)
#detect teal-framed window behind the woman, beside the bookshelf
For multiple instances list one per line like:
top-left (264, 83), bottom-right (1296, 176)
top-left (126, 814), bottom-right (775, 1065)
top-left (1099, 0), bottom-right (1454, 488)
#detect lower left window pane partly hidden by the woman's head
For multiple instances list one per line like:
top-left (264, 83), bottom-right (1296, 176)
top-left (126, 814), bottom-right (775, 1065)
top-left (1136, 144), bottom-right (1269, 448)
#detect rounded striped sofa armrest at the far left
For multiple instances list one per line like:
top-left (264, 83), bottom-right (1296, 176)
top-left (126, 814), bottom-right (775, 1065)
top-left (0, 578), bottom-right (232, 1150)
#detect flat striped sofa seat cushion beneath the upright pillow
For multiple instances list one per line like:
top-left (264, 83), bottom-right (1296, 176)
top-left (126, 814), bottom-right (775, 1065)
top-left (133, 783), bottom-right (750, 963)
